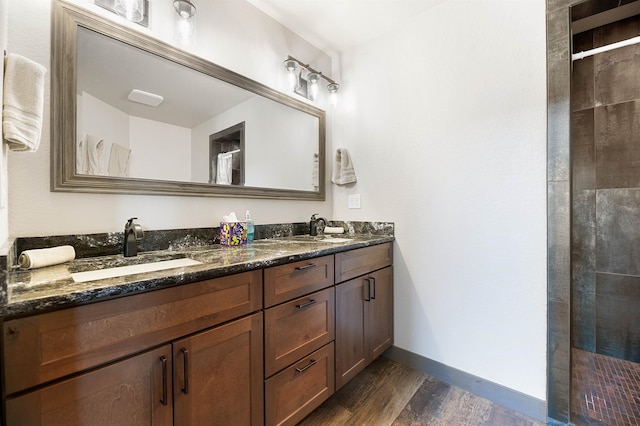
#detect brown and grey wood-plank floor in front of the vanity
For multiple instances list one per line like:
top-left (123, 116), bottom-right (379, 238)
top-left (299, 357), bottom-right (545, 426)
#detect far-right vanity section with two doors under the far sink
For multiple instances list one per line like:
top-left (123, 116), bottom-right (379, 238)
top-left (335, 244), bottom-right (393, 390)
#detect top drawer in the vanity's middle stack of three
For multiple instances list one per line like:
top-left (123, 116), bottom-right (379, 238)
top-left (264, 255), bottom-right (333, 308)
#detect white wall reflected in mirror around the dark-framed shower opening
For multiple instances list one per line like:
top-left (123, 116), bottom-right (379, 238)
top-left (192, 96), bottom-right (319, 191)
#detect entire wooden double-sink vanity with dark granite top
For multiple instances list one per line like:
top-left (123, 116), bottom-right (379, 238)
top-left (2, 225), bottom-right (393, 426)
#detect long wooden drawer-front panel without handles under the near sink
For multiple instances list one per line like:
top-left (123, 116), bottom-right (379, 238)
top-left (3, 271), bottom-right (262, 394)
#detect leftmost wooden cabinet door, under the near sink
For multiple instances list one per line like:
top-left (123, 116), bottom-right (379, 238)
top-left (6, 345), bottom-right (173, 426)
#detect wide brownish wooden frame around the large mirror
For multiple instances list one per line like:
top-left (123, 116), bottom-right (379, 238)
top-left (51, 1), bottom-right (326, 201)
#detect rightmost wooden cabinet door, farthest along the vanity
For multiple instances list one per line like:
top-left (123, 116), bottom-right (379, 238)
top-left (365, 267), bottom-right (393, 362)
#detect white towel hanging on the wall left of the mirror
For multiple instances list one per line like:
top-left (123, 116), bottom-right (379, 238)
top-left (2, 53), bottom-right (47, 152)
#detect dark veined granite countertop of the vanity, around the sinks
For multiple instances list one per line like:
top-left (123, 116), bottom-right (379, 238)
top-left (2, 234), bottom-right (394, 318)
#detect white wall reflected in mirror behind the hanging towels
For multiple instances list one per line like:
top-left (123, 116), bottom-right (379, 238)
top-left (77, 92), bottom-right (191, 182)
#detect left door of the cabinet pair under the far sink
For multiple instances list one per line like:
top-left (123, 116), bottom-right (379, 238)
top-left (336, 277), bottom-right (369, 390)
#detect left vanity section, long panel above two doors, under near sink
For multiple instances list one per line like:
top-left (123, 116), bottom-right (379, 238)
top-left (3, 271), bottom-right (264, 426)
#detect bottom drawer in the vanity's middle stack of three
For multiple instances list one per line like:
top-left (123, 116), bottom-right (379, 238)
top-left (265, 343), bottom-right (335, 426)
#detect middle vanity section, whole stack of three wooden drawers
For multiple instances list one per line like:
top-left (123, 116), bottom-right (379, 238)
top-left (264, 255), bottom-right (335, 426)
